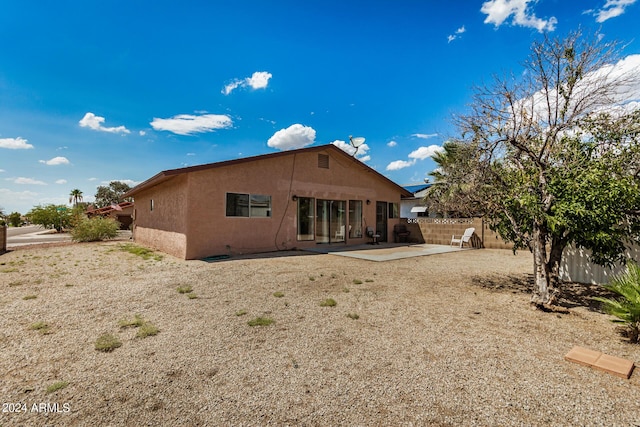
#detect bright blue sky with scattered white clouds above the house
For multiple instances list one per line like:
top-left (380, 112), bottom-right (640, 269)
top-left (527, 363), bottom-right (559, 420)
top-left (0, 0), bottom-right (640, 213)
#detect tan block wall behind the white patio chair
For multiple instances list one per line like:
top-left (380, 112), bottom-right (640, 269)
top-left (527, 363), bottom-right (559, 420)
top-left (401, 218), bottom-right (513, 249)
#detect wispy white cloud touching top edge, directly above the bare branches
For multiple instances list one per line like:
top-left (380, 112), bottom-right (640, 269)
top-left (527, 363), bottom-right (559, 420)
top-left (480, 0), bottom-right (558, 32)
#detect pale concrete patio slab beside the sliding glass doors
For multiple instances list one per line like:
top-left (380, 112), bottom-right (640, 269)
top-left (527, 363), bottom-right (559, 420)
top-left (310, 243), bottom-right (468, 262)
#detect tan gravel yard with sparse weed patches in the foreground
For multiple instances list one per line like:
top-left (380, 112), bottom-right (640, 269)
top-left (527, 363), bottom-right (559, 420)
top-left (0, 241), bottom-right (640, 426)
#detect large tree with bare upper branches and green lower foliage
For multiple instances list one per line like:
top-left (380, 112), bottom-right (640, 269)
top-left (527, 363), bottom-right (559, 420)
top-left (432, 32), bottom-right (640, 305)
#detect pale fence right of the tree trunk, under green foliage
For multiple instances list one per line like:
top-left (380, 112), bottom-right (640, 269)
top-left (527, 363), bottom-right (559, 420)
top-left (560, 245), bottom-right (640, 284)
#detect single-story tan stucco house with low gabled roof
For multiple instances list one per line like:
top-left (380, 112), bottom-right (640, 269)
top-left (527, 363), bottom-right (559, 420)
top-left (124, 144), bottom-right (411, 259)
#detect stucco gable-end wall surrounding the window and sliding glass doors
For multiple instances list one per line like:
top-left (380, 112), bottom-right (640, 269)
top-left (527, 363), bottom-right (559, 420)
top-left (180, 148), bottom-right (400, 259)
